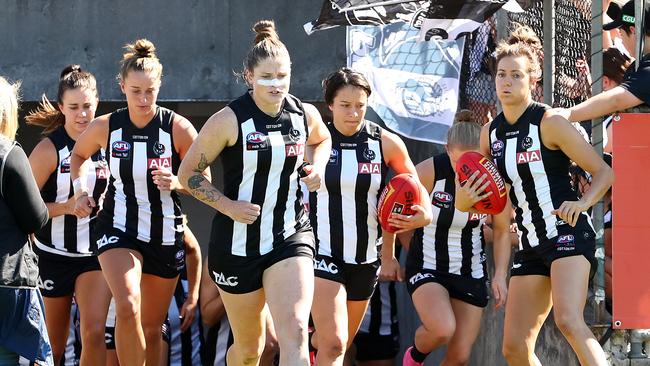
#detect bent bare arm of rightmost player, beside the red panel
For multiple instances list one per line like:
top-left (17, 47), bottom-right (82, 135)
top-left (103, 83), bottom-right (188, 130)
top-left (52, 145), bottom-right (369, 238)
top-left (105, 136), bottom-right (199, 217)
top-left (541, 112), bottom-right (614, 226)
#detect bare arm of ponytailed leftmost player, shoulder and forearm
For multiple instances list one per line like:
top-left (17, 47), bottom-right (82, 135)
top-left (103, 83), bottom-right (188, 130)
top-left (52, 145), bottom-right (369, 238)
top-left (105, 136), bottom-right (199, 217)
top-left (29, 138), bottom-right (75, 217)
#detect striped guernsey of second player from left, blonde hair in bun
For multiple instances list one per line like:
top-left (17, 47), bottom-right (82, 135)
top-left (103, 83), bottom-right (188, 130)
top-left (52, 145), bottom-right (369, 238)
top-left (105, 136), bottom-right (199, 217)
top-left (98, 107), bottom-right (183, 245)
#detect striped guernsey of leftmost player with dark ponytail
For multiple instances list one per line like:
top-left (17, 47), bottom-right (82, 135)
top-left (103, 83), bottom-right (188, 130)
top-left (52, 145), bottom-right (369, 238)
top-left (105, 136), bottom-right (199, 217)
top-left (35, 126), bottom-right (109, 257)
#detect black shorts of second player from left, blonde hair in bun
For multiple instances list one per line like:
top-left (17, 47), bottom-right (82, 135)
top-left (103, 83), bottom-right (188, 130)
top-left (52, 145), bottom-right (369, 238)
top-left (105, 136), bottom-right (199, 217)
top-left (95, 223), bottom-right (185, 278)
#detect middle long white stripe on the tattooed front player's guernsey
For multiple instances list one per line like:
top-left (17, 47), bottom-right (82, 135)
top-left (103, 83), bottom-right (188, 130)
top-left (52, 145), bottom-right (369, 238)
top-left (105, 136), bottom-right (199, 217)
top-left (258, 131), bottom-right (286, 254)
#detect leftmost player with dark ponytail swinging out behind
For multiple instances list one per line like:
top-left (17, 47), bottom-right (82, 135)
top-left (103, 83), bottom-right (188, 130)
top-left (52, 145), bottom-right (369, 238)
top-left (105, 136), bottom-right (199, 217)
top-left (27, 65), bottom-right (111, 365)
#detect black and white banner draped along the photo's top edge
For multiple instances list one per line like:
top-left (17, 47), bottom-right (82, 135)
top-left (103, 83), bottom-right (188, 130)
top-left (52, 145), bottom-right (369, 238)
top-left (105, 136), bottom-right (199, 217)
top-left (304, 0), bottom-right (530, 35)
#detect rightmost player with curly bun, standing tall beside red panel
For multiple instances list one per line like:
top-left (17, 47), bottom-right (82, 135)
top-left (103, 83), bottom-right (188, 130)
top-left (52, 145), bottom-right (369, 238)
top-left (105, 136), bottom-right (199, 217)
top-left (481, 26), bottom-right (616, 365)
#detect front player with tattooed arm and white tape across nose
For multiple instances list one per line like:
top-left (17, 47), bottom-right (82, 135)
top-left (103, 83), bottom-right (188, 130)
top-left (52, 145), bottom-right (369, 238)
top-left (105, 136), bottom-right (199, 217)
top-left (179, 20), bottom-right (331, 365)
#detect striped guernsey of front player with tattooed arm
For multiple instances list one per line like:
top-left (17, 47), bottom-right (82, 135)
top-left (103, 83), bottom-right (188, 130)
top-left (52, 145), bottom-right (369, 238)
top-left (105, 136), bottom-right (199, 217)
top-left (210, 92), bottom-right (309, 257)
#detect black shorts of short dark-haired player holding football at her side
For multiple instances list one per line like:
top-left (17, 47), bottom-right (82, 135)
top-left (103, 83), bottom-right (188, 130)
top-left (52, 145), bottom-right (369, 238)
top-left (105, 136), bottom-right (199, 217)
top-left (314, 254), bottom-right (379, 301)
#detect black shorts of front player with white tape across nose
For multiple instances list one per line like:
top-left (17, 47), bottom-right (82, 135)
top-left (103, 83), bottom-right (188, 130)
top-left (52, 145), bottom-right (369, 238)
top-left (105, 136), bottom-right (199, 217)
top-left (208, 228), bottom-right (314, 294)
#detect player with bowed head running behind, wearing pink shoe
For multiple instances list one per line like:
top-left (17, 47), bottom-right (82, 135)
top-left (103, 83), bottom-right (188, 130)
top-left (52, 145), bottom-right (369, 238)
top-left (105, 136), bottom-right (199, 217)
top-left (396, 113), bottom-right (512, 366)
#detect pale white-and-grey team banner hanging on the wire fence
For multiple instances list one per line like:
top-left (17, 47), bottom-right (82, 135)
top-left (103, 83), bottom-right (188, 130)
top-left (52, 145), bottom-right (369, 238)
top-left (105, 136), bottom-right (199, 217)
top-left (347, 23), bottom-right (464, 143)
